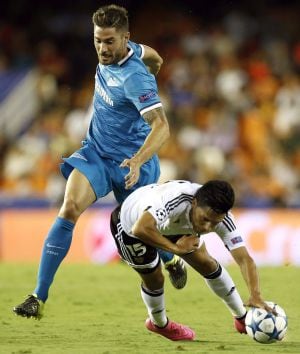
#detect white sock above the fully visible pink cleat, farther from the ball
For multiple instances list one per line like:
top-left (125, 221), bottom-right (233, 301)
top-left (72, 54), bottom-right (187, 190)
top-left (141, 285), bottom-right (168, 327)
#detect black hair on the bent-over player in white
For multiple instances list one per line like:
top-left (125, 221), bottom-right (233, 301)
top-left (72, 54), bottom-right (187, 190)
top-left (195, 180), bottom-right (234, 214)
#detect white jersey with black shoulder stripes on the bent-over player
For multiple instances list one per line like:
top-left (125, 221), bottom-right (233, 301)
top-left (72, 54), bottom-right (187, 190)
top-left (120, 180), bottom-right (245, 250)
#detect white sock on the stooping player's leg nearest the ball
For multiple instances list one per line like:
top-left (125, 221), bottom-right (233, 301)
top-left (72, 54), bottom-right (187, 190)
top-left (205, 264), bottom-right (247, 317)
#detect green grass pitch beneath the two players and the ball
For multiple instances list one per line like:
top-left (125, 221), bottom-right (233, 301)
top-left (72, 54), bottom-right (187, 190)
top-left (0, 263), bottom-right (300, 354)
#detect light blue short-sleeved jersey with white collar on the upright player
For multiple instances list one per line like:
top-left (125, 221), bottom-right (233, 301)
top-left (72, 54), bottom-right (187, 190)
top-left (86, 41), bottom-right (162, 162)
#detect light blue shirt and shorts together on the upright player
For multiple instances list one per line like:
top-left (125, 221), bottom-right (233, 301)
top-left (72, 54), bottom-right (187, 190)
top-left (61, 42), bottom-right (162, 203)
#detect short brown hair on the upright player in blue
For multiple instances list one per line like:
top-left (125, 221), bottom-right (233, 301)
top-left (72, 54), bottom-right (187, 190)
top-left (93, 5), bottom-right (129, 31)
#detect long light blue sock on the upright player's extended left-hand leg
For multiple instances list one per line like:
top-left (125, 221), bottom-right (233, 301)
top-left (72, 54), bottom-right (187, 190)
top-left (33, 217), bottom-right (75, 302)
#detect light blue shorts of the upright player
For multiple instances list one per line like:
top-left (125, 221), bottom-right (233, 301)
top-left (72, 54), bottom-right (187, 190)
top-left (60, 144), bottom-right (160, 203)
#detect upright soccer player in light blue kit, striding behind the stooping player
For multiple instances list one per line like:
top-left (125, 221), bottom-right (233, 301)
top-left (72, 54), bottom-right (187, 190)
top-left (13, 5), bottom-right (186, 319)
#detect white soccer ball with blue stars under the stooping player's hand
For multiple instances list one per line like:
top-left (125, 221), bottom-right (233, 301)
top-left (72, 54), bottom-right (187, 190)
top-left (245, 301), bottom-right (288, 344)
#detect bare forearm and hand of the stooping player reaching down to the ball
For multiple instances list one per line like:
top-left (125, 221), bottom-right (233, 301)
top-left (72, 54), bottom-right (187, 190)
top-left (231, 246), bottom-right (272, 312)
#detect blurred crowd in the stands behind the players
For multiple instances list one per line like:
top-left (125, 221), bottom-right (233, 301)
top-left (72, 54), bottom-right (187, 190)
top-left (0, 0), bottom-right (300, 207)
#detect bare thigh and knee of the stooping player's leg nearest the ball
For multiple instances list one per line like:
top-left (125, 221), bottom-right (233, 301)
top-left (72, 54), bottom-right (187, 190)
top-left (182, 242), bottom-right (217, 276)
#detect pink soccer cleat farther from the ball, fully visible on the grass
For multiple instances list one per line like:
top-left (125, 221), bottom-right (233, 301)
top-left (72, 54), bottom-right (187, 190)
top-left (145, 318), bottom-right (196, 341)
